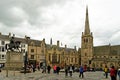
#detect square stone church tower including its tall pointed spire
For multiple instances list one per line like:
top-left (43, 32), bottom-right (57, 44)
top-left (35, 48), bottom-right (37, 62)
top-left (81, 7), bottom-right (93, 67)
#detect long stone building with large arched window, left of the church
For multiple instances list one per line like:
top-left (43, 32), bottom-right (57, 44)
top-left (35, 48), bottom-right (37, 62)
top-left (46, 38), bottom-right (79, 67)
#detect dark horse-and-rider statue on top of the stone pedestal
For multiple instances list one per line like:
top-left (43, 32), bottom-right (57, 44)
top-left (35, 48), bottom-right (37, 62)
top-left (6, 37), bottom-right (21, 52)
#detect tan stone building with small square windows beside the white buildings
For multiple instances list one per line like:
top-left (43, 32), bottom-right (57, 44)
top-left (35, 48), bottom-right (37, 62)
top-left (27, 39), bottom-right (45, 65)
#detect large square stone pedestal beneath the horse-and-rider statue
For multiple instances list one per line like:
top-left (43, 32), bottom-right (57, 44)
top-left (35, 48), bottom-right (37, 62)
top-left (5, 51), bottom-right (24, 70)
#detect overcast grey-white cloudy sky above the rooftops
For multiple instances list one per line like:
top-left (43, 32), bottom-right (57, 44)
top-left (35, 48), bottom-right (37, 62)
top-left (0, 0), bottom-right (120, 48)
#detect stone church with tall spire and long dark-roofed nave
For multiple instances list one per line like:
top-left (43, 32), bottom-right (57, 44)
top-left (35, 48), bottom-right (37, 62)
top-left (79, 7), bottom-right (120, 68)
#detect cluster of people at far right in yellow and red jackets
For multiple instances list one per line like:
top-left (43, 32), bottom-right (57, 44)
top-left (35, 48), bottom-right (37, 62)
top-left (104, 66), bottom-right (120, 80)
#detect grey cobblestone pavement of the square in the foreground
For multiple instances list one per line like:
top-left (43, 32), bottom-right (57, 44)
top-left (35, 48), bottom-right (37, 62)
top-left (0, 71), bottom-right (119, 80)
